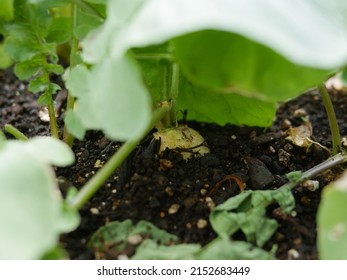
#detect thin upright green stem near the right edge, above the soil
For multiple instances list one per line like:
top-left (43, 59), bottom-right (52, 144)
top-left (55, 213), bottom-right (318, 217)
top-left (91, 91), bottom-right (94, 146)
top-left (318, 83), bottom-right (341, 155)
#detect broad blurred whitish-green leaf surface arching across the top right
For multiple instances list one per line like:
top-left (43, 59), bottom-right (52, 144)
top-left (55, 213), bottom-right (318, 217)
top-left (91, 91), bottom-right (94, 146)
top-left (100, 0), bottom-right (347, 69)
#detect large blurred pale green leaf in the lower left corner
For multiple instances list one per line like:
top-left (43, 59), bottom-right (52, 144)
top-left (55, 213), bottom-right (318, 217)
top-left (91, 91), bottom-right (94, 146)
top-left (0, 137), bottom-right (79, 259)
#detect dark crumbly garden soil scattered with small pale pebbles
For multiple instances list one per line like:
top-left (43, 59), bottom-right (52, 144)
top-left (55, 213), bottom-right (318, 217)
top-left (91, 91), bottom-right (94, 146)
top-left (0, 70), bottom-right (347, 259)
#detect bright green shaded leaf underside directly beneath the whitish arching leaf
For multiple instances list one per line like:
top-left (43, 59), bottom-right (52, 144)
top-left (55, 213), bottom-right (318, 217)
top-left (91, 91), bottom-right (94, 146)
top-left (173, 31), bottom-right (330, 102)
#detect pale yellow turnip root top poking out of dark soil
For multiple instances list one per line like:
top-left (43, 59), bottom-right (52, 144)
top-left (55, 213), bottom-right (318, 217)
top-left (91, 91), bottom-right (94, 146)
top-left (154, 125), bottom-right (210, 161)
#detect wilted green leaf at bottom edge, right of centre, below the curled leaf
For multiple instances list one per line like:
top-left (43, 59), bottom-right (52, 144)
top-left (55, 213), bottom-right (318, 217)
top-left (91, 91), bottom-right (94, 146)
top-left (197, 238), bottom-right (274, 260)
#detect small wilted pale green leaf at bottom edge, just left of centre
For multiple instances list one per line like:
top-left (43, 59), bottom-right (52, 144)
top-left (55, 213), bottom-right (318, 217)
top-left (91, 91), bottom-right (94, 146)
top-left (131, 239), bottom-right (201, 260)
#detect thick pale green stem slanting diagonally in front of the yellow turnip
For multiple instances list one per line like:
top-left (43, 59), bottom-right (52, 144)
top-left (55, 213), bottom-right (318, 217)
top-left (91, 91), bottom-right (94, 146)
top-left (70, 106), bottom-right (170, 209)
